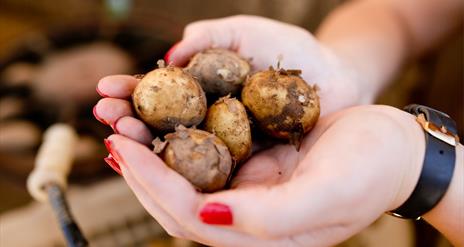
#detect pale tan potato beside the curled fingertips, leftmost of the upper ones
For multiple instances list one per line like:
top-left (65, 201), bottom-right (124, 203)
top-left (132, 62), bottom-right (207, 131)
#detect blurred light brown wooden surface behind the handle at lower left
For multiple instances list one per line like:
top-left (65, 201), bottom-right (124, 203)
top-left (0, 178), bottom-right (165, 247)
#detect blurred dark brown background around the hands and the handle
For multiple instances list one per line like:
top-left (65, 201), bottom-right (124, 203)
top-left (0, 0), bottom-right (464, 247)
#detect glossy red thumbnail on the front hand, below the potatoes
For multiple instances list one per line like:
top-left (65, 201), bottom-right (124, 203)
top-left (199, 202), bottom-right (233, 225)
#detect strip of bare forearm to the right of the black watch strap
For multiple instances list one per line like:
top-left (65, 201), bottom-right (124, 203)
top-left (424, 145), bottom-right (464, 246)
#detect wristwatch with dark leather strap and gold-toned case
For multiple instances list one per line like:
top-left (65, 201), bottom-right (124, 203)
top-left (390, 104), bottom-right (459, 219)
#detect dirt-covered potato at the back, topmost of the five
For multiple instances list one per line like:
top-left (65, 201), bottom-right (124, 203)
top-left (185, 49), bottom-right (251, 96)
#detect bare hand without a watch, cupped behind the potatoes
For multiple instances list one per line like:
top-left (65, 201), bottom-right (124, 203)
top-left (165, 16), bottom-right (374, 115)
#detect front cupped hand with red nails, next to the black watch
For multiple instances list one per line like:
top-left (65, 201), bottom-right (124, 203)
top-left (95, 76), bottom-right (425, 246)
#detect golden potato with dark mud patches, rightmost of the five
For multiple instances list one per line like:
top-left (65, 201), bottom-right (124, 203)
top-left (242, 67), bottom-right (320, 150)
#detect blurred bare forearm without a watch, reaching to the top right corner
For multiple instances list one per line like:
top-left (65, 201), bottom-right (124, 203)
top-left (317, 0), bottom-right (464, 100)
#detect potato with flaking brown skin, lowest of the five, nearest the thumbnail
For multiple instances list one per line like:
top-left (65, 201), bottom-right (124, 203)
top-left (153, 125), bottom-right (232, 192)
